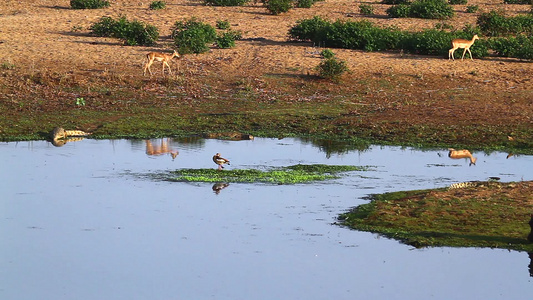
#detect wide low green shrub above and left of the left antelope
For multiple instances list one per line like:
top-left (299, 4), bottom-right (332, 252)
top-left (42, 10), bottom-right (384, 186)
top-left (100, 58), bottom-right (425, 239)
top-left (89, 16), bottom-right (159, 46)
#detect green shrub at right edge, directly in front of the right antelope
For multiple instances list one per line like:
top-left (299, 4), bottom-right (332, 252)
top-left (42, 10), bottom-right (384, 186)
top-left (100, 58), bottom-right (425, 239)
top-left (489, 34), bottom-right (533, 59)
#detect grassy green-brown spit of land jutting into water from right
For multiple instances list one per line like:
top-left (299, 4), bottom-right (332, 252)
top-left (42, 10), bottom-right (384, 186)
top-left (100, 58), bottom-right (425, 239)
top-left (338, 181), bottom-right (533, 252)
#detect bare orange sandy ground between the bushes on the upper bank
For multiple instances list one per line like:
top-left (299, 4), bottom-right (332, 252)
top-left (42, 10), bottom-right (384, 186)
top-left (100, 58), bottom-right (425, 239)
top-left (0, 0), bottom-right (533, 83)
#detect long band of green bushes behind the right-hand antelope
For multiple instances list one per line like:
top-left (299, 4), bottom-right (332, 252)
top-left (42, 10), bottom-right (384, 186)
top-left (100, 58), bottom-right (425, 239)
top-left (288, 12), bottom-right (533, 59)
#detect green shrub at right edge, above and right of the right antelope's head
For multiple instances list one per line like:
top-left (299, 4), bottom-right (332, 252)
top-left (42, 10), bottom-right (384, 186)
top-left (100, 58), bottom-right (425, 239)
top-left (477, 11), bottom-right (533, 36)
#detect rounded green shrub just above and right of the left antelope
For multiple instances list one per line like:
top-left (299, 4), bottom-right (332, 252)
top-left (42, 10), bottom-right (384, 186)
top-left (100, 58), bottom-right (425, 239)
top-left (171, 18), bottom-right (217, 54)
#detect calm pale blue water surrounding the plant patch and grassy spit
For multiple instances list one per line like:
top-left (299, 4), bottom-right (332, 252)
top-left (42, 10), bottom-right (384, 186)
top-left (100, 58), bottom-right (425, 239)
top-left (0, 139), bottom-right (533, 300)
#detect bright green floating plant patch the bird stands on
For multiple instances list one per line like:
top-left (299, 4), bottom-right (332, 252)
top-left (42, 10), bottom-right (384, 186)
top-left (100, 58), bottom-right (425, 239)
top-left (168, 164), bottom-right (367, 184)
